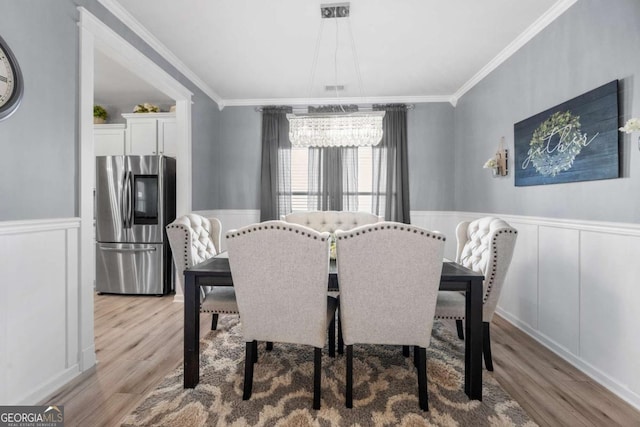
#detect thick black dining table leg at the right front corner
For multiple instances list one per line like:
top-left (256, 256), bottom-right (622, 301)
top-left (464, 279), bottom-right (482, 400)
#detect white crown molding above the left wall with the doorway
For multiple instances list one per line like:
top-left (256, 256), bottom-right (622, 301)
top-left (98, 0), bottom-right (224, 110)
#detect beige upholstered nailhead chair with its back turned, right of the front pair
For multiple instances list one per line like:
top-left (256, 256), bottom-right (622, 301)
top-left (336, 222), bottom-right (445, 411)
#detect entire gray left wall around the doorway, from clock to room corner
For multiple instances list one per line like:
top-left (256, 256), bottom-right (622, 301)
top-left (0, 0), bottom-right (219, 221)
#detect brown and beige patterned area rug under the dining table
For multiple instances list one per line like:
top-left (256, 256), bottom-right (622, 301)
top-left (123, 316), bottom-right (536, 427)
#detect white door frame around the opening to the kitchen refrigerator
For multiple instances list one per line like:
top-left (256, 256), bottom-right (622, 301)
top-left (78, 7), bottom-right (193, 371)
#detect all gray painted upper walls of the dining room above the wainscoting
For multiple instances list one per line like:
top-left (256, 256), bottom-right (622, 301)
top-left (5, 0), bottom-right (640, 222)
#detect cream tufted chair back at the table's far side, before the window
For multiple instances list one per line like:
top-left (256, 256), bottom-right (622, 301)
top-left (282, 211), bottom-right (383, 233)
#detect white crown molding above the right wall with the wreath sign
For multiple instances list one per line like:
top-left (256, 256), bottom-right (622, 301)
top-left (451, 0), bottom-right (578, 106)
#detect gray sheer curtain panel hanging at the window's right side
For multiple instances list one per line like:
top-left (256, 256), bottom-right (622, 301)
top-left (373, 104), bottom-right (411, 224)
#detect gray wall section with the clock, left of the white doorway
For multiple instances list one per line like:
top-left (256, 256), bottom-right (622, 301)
top-left (0, 0), bottom-right (78, 220)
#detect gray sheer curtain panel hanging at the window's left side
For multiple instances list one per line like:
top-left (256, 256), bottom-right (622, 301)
top-left (260, 107), bottom-right (291, 221)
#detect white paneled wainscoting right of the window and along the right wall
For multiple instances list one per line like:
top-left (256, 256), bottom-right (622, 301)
top-left (411, 211), bottom-right (640, 409)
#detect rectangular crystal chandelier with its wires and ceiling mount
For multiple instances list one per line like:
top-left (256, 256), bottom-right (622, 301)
top-left (287, 3), bottom-right (385, 147)
